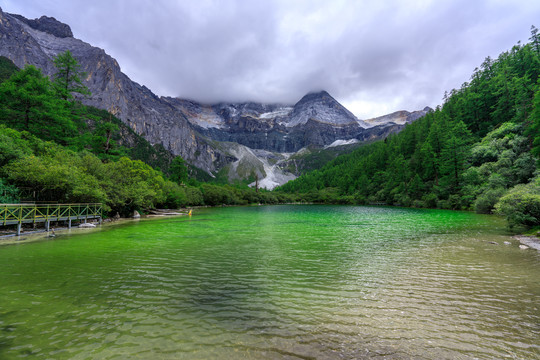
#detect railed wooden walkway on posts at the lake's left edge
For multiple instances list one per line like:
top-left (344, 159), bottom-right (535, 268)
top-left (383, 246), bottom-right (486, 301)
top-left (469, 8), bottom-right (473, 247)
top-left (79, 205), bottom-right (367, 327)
top-left (0, 203), bottom-right (103, 235)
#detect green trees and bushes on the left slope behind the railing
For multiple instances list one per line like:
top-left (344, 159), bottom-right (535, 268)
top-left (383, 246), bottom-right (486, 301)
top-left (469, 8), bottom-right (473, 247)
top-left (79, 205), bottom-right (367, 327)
top-left (0, 52), bottom-right (287, 215)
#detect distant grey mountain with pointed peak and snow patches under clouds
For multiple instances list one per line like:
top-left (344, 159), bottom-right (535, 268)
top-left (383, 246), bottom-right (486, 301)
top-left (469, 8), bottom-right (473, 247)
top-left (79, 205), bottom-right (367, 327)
top-left (169, 91), bottom-right (431, 153)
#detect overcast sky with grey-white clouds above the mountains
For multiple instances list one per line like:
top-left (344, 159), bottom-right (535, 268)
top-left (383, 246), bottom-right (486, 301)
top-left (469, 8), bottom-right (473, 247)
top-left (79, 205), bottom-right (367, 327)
top-left (0, 0), bottom-right (540, 119)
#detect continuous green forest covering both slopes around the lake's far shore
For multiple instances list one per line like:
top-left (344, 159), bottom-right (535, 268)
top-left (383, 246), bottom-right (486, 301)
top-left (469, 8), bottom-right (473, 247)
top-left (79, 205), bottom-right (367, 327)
top-left (0, 27), bottom-right (540, 226)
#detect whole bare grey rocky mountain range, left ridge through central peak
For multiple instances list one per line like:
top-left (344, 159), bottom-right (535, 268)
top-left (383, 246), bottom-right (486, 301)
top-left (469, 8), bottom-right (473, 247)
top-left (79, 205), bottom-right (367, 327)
top-left (0, 9), bottom-right (427, 188)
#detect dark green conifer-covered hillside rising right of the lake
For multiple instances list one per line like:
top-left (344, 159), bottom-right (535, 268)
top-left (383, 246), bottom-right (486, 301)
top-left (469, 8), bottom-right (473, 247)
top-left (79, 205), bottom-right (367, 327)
top-left (278, 27), bottom-right (540, 225)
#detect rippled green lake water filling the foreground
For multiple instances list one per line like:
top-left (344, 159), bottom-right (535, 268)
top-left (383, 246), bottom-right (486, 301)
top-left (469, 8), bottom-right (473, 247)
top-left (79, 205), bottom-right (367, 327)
top-left (0, 205), bottom-right (540, 359)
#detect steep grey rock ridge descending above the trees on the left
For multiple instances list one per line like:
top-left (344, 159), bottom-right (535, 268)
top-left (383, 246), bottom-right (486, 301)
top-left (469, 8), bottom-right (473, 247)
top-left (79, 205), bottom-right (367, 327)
top-left (0, 10), bottom-right (228, 172)
